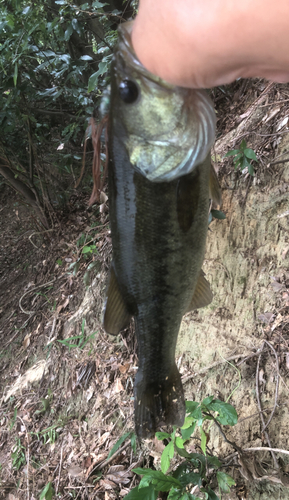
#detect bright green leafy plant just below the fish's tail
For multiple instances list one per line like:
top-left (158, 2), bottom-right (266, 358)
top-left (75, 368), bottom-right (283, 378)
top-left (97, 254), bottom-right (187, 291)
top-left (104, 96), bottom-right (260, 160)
top-left (124, 396), bottom-right (238, 500)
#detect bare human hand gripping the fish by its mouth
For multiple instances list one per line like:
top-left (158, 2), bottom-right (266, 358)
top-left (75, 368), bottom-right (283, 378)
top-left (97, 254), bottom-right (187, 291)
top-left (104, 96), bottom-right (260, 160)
top-left (132, 0), bottom-right (289, 88)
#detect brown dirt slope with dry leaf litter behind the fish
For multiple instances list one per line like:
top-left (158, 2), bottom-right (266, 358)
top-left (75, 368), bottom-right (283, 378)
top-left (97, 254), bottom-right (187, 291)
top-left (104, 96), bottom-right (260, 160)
top-left (0, 80), bottom-right (289, 500)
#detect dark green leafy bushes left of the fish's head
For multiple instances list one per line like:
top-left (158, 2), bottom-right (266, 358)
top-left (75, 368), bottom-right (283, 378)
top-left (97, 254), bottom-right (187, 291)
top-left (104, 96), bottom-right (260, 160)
top-left (0, 0), bottom-right (122, 227)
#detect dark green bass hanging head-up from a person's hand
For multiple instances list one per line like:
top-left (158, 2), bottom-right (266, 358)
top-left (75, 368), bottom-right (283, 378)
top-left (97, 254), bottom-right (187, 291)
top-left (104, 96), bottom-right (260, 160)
top-left (103, 22), bottom-right (221, 439)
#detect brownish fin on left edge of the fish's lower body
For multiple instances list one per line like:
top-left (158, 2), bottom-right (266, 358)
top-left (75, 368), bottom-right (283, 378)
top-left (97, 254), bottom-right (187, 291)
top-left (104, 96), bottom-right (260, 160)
top-left (103, 267), bottom-right (131, 335)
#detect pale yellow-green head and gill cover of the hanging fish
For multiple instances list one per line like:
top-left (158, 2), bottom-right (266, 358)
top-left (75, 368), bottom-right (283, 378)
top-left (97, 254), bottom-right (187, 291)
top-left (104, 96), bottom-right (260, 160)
top-left (113, 21), bottom-right (216, 182)
